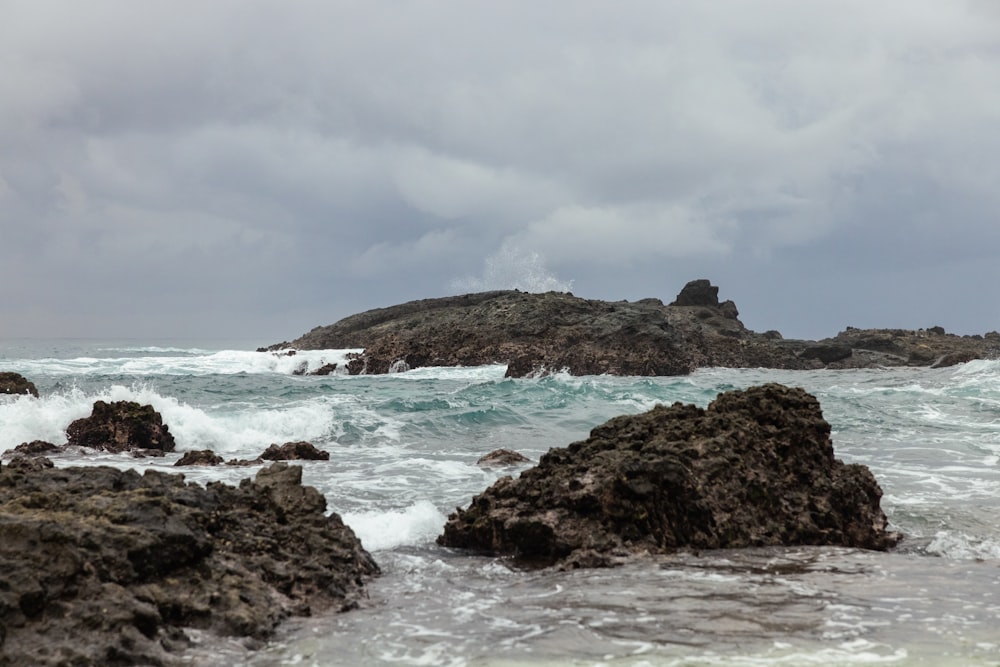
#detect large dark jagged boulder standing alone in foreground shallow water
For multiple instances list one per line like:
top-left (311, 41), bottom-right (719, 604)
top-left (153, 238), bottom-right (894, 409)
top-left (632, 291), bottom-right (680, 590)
top-left (438, 384), bottom-right (898, 567)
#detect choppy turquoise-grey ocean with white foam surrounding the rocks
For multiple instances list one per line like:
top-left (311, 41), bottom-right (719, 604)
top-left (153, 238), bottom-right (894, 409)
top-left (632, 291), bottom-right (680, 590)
top-left (0, 340), bottom-right (1000, 667)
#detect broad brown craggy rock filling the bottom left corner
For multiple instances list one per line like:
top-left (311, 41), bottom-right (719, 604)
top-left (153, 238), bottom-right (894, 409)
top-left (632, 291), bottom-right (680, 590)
top-left (0, 459), bottom-right (378, 666)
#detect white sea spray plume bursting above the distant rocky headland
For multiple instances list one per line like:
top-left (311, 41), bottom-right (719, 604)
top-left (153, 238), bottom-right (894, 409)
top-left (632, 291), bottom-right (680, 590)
top-left (449, 244), bottom-right (573, 293)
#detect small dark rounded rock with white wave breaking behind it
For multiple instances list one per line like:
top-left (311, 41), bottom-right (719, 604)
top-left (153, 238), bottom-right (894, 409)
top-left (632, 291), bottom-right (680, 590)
top-left (66, 401), bottom-right (175, 452)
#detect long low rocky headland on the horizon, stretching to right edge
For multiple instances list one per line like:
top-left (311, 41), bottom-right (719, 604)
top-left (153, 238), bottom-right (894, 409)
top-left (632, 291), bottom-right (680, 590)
top-left (260, 279), bottom-right (1000, 377)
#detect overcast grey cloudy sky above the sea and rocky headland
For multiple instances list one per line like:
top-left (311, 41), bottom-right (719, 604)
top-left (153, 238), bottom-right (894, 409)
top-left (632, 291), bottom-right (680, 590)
top-left (0, 0), bottom-right (1000, 345)
